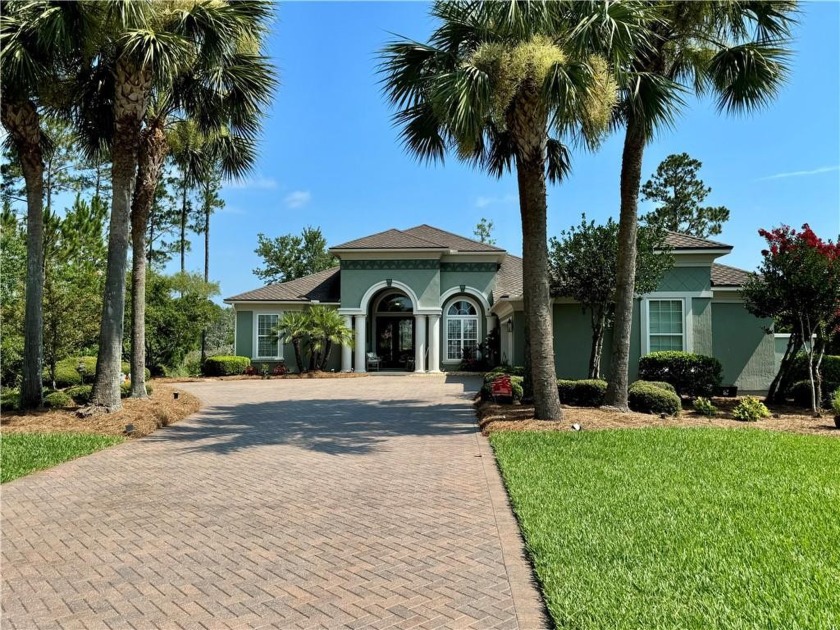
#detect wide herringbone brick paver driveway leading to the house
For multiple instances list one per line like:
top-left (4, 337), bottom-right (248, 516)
top-left (2, 376), bottom-right (543, 628)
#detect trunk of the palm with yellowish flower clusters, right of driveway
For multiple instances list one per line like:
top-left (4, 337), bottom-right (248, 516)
top-left (516, 159), bottom-right (563, 420)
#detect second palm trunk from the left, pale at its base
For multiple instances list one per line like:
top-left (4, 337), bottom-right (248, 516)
top-left (88, 61), bottom-right (151, 415)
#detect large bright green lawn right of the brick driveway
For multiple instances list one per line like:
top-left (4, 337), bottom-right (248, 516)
top-left (491, 429), bottom-right (840, 630)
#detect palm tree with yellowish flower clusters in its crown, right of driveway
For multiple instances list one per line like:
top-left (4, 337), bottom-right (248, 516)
top-left (381, 0), bottom-right (642, 419)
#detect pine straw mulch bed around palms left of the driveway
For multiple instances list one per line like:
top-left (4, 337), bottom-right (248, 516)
top-left (0, 381), bottom-right (201, 437)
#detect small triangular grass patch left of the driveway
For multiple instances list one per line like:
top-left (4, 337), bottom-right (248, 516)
top-left (0, 433), bottom-right (123, 483)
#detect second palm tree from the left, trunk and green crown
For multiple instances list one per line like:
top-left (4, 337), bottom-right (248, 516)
top-left (78, 0), bottom-right (270, 413)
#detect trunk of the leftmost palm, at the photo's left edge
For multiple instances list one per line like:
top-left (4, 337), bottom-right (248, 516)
top-left (0, 98), bottom-right (44, 410)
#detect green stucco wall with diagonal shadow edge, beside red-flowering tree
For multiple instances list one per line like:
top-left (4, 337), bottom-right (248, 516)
top-left (712, 302), bottom-right (776, 391)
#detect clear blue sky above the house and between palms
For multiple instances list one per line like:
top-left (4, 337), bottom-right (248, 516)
top-left (188, 2), bottom-right (840, 296)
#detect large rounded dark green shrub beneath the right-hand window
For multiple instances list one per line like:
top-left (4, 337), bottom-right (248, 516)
top-left (639, 351), bottom-right (723, 397)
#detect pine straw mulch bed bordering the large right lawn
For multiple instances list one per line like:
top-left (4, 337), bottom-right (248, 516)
top-left (476, 398), bottom-right (840, 437)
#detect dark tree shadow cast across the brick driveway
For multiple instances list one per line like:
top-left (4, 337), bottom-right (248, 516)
top-left (144, 377), bottom-right (482, 455)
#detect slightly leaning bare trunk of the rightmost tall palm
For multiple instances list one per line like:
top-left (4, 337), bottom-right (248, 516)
top-left (606, 116), bottom-right (645, 411)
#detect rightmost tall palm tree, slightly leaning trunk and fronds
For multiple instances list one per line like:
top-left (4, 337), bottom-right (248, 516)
top-left (606, 1), bottom-right (794, 410)
